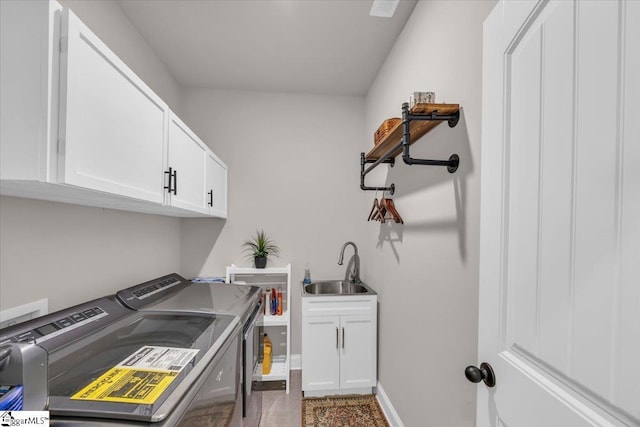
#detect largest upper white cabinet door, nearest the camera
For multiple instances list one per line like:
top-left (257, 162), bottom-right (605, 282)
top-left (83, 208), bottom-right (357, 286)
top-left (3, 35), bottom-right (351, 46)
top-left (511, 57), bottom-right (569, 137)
top-left (58, 10), bottom-right (169, 204)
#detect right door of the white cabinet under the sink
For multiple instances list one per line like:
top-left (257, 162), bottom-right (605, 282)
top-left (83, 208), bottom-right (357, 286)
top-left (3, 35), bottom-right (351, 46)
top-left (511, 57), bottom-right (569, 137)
top-left (340, 316), bottom-right (377, 389)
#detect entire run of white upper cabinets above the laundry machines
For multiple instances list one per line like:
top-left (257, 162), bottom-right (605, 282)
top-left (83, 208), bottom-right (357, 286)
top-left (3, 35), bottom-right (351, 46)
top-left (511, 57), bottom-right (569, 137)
top-left (0, 0), bottom-right (226, 221)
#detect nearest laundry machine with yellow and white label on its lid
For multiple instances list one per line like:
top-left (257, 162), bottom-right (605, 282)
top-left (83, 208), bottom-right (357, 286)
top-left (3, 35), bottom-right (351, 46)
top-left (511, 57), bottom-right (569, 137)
top-left (0, 296), bottom-right (242, 427)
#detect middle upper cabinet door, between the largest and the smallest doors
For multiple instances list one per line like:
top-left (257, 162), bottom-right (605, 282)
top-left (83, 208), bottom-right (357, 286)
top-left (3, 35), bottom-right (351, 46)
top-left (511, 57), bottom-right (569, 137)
top-left (165, 114), bottom-right (208, 213)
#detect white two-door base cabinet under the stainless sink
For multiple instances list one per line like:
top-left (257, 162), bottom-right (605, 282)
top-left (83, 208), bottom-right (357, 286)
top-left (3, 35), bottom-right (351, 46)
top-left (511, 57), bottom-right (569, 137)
top-left (302, 295), bottom-right (377, 397)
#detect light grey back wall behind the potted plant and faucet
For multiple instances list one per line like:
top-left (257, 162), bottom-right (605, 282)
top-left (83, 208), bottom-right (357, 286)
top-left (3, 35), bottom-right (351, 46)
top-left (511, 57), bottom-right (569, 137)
top-left (182, 89), bottom-right (368, 354)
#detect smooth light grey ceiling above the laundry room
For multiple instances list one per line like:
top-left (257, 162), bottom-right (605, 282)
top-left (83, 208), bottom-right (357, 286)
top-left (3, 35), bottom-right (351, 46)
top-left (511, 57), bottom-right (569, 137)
top-left (118, 0), bottom-right (417, 95)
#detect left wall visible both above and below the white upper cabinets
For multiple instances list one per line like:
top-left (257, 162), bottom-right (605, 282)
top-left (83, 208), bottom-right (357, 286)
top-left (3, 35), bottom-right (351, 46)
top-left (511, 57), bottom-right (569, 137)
top-left (0, 0), bottom-right (185, 311)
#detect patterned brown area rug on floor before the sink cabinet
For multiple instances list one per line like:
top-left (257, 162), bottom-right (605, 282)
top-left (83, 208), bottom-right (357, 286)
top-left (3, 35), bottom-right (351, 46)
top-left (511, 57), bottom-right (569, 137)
top-left (302, 395), bottom-right (389, 427)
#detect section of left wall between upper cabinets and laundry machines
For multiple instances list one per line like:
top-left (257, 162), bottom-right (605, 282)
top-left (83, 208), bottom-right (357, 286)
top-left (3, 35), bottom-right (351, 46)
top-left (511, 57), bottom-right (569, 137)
top-left (0, 197), bottom-right (180, 311)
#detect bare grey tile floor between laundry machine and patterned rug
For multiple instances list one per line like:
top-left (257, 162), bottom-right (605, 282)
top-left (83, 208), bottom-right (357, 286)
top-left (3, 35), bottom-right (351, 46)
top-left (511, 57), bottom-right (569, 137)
top-left (260, 369), bottom-right (302, 427)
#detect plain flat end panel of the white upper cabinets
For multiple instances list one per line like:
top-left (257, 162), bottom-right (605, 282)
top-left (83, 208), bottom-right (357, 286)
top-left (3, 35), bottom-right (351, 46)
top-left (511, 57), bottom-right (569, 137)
top-left (0, 1), bottom-right (62, 184)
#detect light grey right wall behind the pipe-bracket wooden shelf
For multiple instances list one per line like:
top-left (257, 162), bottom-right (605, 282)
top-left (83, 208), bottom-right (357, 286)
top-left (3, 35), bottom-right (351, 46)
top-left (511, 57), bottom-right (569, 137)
top-left (362, 0), bottom-right (495, 427)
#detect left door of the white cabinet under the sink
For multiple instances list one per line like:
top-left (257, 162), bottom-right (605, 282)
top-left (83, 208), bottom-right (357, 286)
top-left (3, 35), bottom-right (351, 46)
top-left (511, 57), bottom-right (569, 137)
top-left (302, 316), bottom-right (340, 391)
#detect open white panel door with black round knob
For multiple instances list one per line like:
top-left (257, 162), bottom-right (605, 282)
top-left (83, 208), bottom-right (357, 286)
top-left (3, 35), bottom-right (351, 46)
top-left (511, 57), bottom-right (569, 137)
top-left (477, 0), bottom-right (640, 427)
